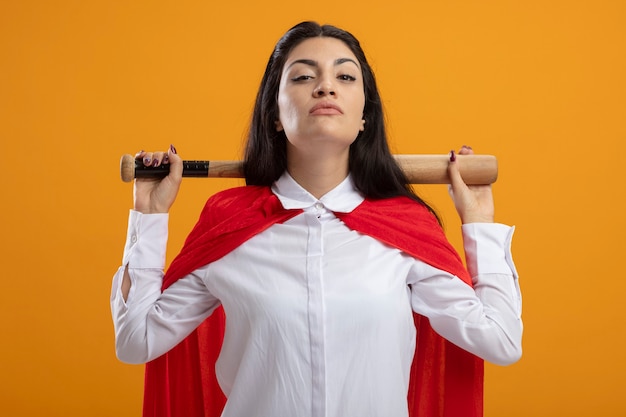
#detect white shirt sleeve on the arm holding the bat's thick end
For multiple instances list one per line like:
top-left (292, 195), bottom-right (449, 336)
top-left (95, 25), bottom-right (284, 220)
top-left (409, 223), bottom-right (523, 365)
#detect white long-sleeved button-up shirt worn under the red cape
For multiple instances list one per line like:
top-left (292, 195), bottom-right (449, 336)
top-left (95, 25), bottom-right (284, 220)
top-left (111, 174), bottom-right (522, 417)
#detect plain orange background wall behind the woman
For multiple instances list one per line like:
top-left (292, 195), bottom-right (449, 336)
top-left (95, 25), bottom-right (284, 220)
top-left (0, 0), bottom-right (626, 417)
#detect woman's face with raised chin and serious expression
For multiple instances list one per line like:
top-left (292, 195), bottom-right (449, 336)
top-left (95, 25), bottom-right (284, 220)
top-left (276, 37), bottom-right (365, 158)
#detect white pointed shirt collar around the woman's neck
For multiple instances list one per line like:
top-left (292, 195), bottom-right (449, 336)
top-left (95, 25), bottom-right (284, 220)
top-left (272, 171), bottom-right (364, 213)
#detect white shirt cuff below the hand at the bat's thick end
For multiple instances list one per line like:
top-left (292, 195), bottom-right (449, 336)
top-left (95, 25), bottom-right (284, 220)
top-left (462, 223), bottom-right (518, 278)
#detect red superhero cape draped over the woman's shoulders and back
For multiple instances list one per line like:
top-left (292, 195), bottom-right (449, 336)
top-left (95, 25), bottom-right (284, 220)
top-left (143, 186), bottom-right (483, 417)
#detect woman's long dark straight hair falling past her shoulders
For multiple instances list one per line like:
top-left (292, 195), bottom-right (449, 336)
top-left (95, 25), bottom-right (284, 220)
top-left (244, 22), bottom-right (436, 215)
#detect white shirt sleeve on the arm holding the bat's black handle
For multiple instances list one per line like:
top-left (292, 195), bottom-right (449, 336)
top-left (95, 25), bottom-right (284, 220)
top-left (111, 210), bottom-right (219, 363)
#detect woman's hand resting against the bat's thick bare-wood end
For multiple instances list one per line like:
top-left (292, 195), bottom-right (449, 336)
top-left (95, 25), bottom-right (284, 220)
top-left (448, 145), bottom-right (494, 224)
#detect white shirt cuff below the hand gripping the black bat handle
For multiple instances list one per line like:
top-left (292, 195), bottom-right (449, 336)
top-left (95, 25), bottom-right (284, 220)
top-left (122, 210), bottom-right (169, 269)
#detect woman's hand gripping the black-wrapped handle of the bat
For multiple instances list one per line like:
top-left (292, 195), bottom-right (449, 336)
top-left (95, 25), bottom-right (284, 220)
top-left (133, 145), bottom-right (183, 214)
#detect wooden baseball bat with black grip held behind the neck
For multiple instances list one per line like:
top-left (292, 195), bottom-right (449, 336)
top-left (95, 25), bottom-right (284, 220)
top-left (120, 154), bottom-right (498, 185)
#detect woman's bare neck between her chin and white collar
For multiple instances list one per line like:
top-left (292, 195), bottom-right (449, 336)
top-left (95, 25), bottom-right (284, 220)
top-left (287, 151), bottom-right (348, 198)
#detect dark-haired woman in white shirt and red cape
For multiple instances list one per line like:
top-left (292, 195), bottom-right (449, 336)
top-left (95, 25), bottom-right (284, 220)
top-left (111, 22), bottom-right (522, 417)
